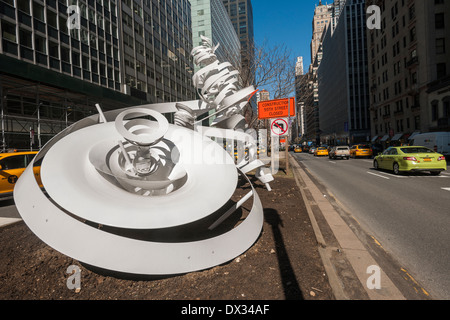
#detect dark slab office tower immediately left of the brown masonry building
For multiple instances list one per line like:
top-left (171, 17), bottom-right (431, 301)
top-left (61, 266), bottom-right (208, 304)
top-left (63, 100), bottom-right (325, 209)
top-left (318, 0), bottom-right (370, 144)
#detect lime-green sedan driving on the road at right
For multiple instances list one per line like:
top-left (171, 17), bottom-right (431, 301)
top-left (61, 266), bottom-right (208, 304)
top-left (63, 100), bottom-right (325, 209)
top-left (373, 146), bottom-right (447, 175)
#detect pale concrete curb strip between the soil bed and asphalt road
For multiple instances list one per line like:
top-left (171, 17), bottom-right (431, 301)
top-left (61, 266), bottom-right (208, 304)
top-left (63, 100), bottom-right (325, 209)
top-left (289, 154), bottom-right (406, 300)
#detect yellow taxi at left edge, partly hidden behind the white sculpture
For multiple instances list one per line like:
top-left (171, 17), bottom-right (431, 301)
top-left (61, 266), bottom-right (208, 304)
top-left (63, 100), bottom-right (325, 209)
top-left (0, 151), bottom-right (42, 198)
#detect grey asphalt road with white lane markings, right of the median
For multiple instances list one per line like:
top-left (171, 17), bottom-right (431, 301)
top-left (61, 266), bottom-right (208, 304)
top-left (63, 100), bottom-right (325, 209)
top-left (294, 153), bottom-right (450, 299)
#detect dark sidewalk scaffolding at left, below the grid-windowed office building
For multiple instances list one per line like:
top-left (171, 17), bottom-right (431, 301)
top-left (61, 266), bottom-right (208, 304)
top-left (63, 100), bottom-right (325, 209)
top-left (0, 74), bottom-right (130, 152)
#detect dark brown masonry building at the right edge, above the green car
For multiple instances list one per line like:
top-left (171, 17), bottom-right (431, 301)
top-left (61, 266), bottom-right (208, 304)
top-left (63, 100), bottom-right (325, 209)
top-left (367, 0), bottom-right (450, 146)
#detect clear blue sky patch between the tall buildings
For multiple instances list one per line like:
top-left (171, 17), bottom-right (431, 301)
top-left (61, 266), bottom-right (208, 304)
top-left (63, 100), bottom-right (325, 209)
top-left (252, 0), bottom-right (320, 71)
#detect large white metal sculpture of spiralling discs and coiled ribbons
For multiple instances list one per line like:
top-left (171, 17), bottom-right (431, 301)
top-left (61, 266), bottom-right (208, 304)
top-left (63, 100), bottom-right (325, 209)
top-left (14, 38), bottom-right (273, 275)
